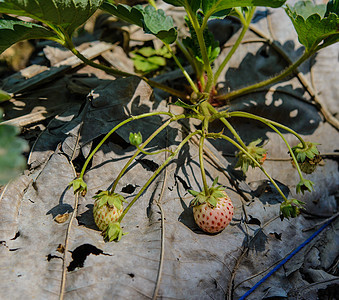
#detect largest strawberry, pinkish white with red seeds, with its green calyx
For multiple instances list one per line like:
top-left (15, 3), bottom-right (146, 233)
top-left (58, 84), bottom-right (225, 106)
top-left (190, 179), bottom-right (234, 233)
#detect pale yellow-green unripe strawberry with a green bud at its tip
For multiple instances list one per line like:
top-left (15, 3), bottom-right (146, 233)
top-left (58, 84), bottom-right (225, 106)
top-left (93, 191), bottom-right (126, 241)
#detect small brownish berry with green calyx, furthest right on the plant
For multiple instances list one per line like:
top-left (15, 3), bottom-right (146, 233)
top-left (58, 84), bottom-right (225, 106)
top-left (292, 142), bottom-right (323, 174)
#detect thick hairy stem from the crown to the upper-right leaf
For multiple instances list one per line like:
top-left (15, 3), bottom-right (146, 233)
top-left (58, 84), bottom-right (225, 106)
top-left (215, 52), bottom-right (314, 100)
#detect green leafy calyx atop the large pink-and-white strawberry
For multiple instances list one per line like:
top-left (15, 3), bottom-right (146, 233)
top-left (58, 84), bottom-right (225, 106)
top-left (188, 177), bottom-right (225, 207)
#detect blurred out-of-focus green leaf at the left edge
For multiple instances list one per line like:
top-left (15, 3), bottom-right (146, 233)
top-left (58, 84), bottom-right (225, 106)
top-left (0, 110), bottom-right (28, 185)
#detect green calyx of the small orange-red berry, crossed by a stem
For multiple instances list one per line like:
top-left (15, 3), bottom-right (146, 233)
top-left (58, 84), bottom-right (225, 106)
top-left (235, 139), bottom-right (267, 174)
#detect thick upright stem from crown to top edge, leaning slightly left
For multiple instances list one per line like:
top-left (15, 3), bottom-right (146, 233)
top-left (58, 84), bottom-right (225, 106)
top-left (185, 0), bottom-right (214, 92)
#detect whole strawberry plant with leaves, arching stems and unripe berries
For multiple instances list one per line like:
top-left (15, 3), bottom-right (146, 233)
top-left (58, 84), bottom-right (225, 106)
top-left (0, 0), bottom-right (339, 241)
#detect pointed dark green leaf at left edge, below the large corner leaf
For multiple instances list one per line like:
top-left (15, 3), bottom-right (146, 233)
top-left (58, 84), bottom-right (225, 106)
top-left (0, 19), bottom-right (58, 54)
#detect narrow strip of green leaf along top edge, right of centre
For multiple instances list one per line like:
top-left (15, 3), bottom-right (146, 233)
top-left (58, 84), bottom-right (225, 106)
top-left (201, 0), bottom-right (286, 15)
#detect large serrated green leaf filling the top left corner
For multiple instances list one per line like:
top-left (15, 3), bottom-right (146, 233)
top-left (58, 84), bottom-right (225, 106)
top-left (0, 0), bottom-right (103, 35)
